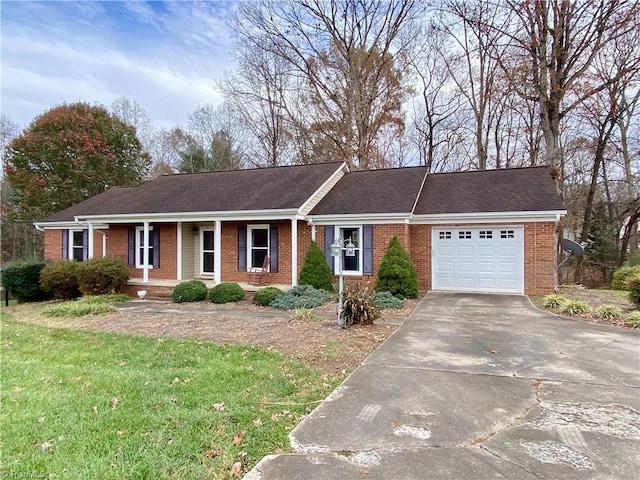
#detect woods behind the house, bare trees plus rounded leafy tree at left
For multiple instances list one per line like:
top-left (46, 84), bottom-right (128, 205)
top-left (0, 0), bottom-right (640, 283)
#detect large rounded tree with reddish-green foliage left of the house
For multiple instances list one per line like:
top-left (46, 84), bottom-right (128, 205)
top-left (4, 103), bottom-right (151, 220)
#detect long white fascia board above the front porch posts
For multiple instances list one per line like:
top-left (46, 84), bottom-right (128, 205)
top-left (76, 209), bottom-right (303, 224)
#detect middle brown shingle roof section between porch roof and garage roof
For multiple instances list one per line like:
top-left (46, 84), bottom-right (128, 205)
top-left (310, 167), bottom-right (427, 215)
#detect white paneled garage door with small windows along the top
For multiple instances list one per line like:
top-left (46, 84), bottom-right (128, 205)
top-left (432, 227), bottom-right (524, 293)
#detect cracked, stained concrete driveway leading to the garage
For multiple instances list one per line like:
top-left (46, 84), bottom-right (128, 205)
top-left (245, 293), bottom-right (640, 480)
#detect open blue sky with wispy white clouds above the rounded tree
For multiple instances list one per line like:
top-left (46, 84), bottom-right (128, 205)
top-left (0, 0), bottom-right (239, 128)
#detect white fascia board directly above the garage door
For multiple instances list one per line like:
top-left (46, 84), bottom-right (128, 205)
top-left (410, 210), bottom-right (567, 225)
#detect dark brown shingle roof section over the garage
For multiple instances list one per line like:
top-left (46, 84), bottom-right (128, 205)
top-left (414, 167), bottom-right (564, 215)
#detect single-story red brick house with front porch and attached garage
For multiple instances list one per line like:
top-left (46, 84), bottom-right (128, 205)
top-left (35, 163), bottom-right (566, 294)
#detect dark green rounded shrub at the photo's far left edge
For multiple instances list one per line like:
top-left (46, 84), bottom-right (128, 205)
top-left (2, 260), bottom-right (51, 303)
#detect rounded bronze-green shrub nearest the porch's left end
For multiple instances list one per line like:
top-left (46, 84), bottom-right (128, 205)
top-left (78, 257), bottom-right (129, 295)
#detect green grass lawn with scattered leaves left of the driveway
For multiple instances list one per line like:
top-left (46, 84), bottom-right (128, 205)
top-left (0, 314), bottom-right (337, 480)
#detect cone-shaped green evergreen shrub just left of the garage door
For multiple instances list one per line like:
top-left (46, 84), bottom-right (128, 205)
top-left (375, 235), bottom-right (418, 298)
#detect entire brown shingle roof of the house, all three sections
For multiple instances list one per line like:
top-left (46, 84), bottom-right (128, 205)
top-left (38, 163), bottom-right (564, 223)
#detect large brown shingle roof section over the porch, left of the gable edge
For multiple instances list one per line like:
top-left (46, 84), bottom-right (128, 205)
top-left (42, 162), bottom-right (342, 223)
